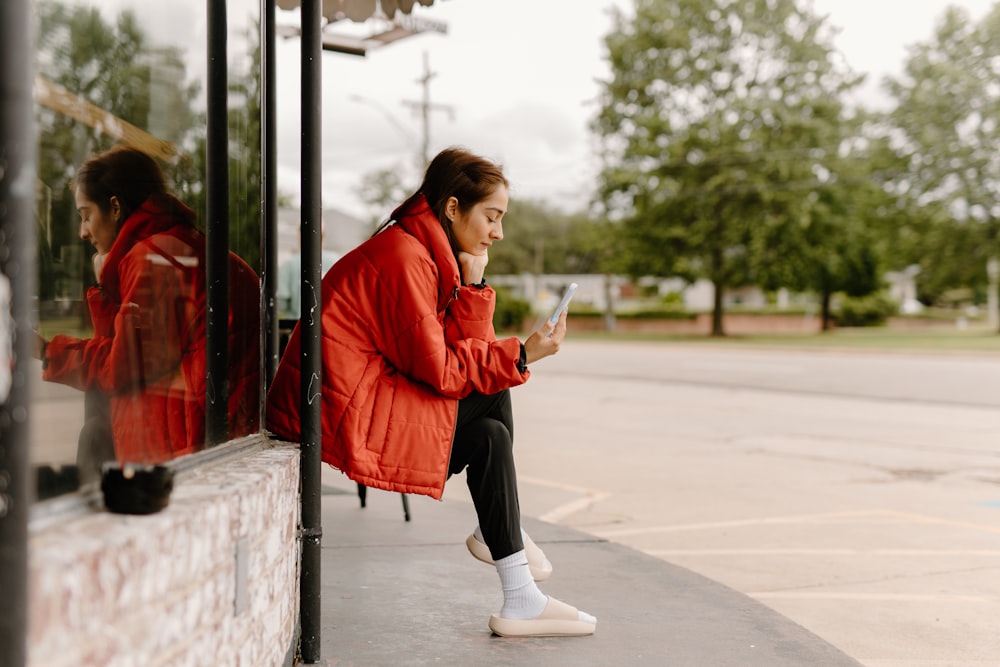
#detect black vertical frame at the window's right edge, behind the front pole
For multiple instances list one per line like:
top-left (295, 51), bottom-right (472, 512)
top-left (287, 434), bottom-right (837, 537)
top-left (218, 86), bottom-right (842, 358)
top-left (260, 0), bottom-right (279, 386)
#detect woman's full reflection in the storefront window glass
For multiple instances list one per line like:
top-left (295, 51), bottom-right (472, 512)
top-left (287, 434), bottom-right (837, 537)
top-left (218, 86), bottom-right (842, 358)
top-left (38, 147), bottom-right (260, 481)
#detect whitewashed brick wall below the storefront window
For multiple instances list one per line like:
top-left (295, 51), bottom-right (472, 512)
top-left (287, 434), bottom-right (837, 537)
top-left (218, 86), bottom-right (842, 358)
top-left (28, 446), bottom-right (299, 667)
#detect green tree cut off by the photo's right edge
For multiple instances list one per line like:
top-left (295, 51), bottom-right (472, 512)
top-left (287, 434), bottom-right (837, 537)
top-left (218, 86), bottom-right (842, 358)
top-left (885, 5), bottom-right (1000, 318)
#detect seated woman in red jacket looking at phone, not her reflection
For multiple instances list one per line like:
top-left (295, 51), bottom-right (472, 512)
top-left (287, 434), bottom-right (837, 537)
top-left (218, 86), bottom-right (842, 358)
top-left (267, 148), bottom-right (596, 636)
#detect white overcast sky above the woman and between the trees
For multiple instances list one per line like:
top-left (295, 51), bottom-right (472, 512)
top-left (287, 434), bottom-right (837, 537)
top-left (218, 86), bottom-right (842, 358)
top-left (270, 0), bottom-right (992, 216)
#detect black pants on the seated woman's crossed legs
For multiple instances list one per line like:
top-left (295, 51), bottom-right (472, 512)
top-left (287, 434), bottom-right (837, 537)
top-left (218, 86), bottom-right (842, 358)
top-left (448, 390), bottom-right (524, 560)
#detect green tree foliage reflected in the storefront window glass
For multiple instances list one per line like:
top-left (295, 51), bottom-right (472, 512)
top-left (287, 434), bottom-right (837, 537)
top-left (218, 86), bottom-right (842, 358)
top-left (36, 0), bottom-right (261, 274)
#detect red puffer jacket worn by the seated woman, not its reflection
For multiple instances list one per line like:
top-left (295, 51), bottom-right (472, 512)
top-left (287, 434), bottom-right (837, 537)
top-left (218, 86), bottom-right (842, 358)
top-left (267, 196), bottom-right (529, 499)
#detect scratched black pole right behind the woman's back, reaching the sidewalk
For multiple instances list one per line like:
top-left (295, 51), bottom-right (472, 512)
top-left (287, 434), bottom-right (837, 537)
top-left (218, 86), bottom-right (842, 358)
top-left (299, 0), bottom-right (323, 664)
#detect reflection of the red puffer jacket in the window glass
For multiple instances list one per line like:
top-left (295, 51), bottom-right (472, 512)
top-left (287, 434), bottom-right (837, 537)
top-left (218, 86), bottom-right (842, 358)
top-left (42, 197), bottom-right (260, 463)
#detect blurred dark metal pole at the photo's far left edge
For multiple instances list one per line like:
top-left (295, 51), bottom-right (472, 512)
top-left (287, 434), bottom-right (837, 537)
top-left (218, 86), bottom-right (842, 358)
top-left (0, 0), bottom-right (38, 667)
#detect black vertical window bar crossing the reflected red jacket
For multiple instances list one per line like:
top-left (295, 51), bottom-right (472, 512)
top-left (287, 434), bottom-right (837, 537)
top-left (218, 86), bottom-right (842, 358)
top-left (205, 0), bottom-right (229, 446)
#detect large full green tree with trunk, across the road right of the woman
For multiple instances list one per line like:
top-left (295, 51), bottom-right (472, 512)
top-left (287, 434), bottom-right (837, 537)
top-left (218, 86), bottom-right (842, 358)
top-left (593, 0), bottom-right (861, 335)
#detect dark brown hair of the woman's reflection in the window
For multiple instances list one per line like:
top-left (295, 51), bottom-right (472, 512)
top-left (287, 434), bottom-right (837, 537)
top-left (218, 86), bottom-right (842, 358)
top-left (74, 146), bottom-right (167, 225)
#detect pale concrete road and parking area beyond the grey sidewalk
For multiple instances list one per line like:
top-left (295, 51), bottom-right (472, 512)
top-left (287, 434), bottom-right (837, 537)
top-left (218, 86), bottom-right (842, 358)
top-left (445, 338), bottom-right (1000, 667)
